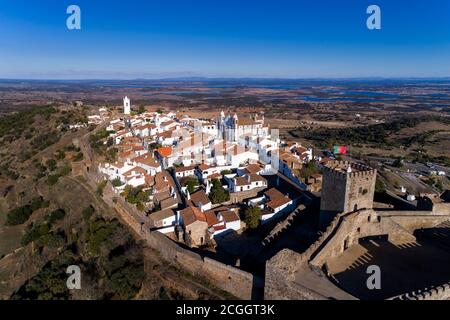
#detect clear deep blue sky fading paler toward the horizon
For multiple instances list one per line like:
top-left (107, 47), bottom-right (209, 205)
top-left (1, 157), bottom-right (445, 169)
top-left (0, 0), bottom-right (450, 79)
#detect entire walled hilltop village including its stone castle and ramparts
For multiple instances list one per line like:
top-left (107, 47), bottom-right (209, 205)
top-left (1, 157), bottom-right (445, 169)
top-left (74, 97), bottom-right (450, 299)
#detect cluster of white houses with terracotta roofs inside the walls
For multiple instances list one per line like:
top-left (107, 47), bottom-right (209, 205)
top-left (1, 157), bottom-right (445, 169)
top-left (98, 97), bottom-right (321, 246)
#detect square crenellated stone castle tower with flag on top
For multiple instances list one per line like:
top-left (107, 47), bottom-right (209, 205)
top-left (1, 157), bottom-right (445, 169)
top-left (320, 161), bottom-right (377, 227)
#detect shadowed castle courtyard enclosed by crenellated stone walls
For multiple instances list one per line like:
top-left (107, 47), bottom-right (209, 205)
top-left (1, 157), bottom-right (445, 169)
top-left (328, 238), bottom-right (450, 299)
